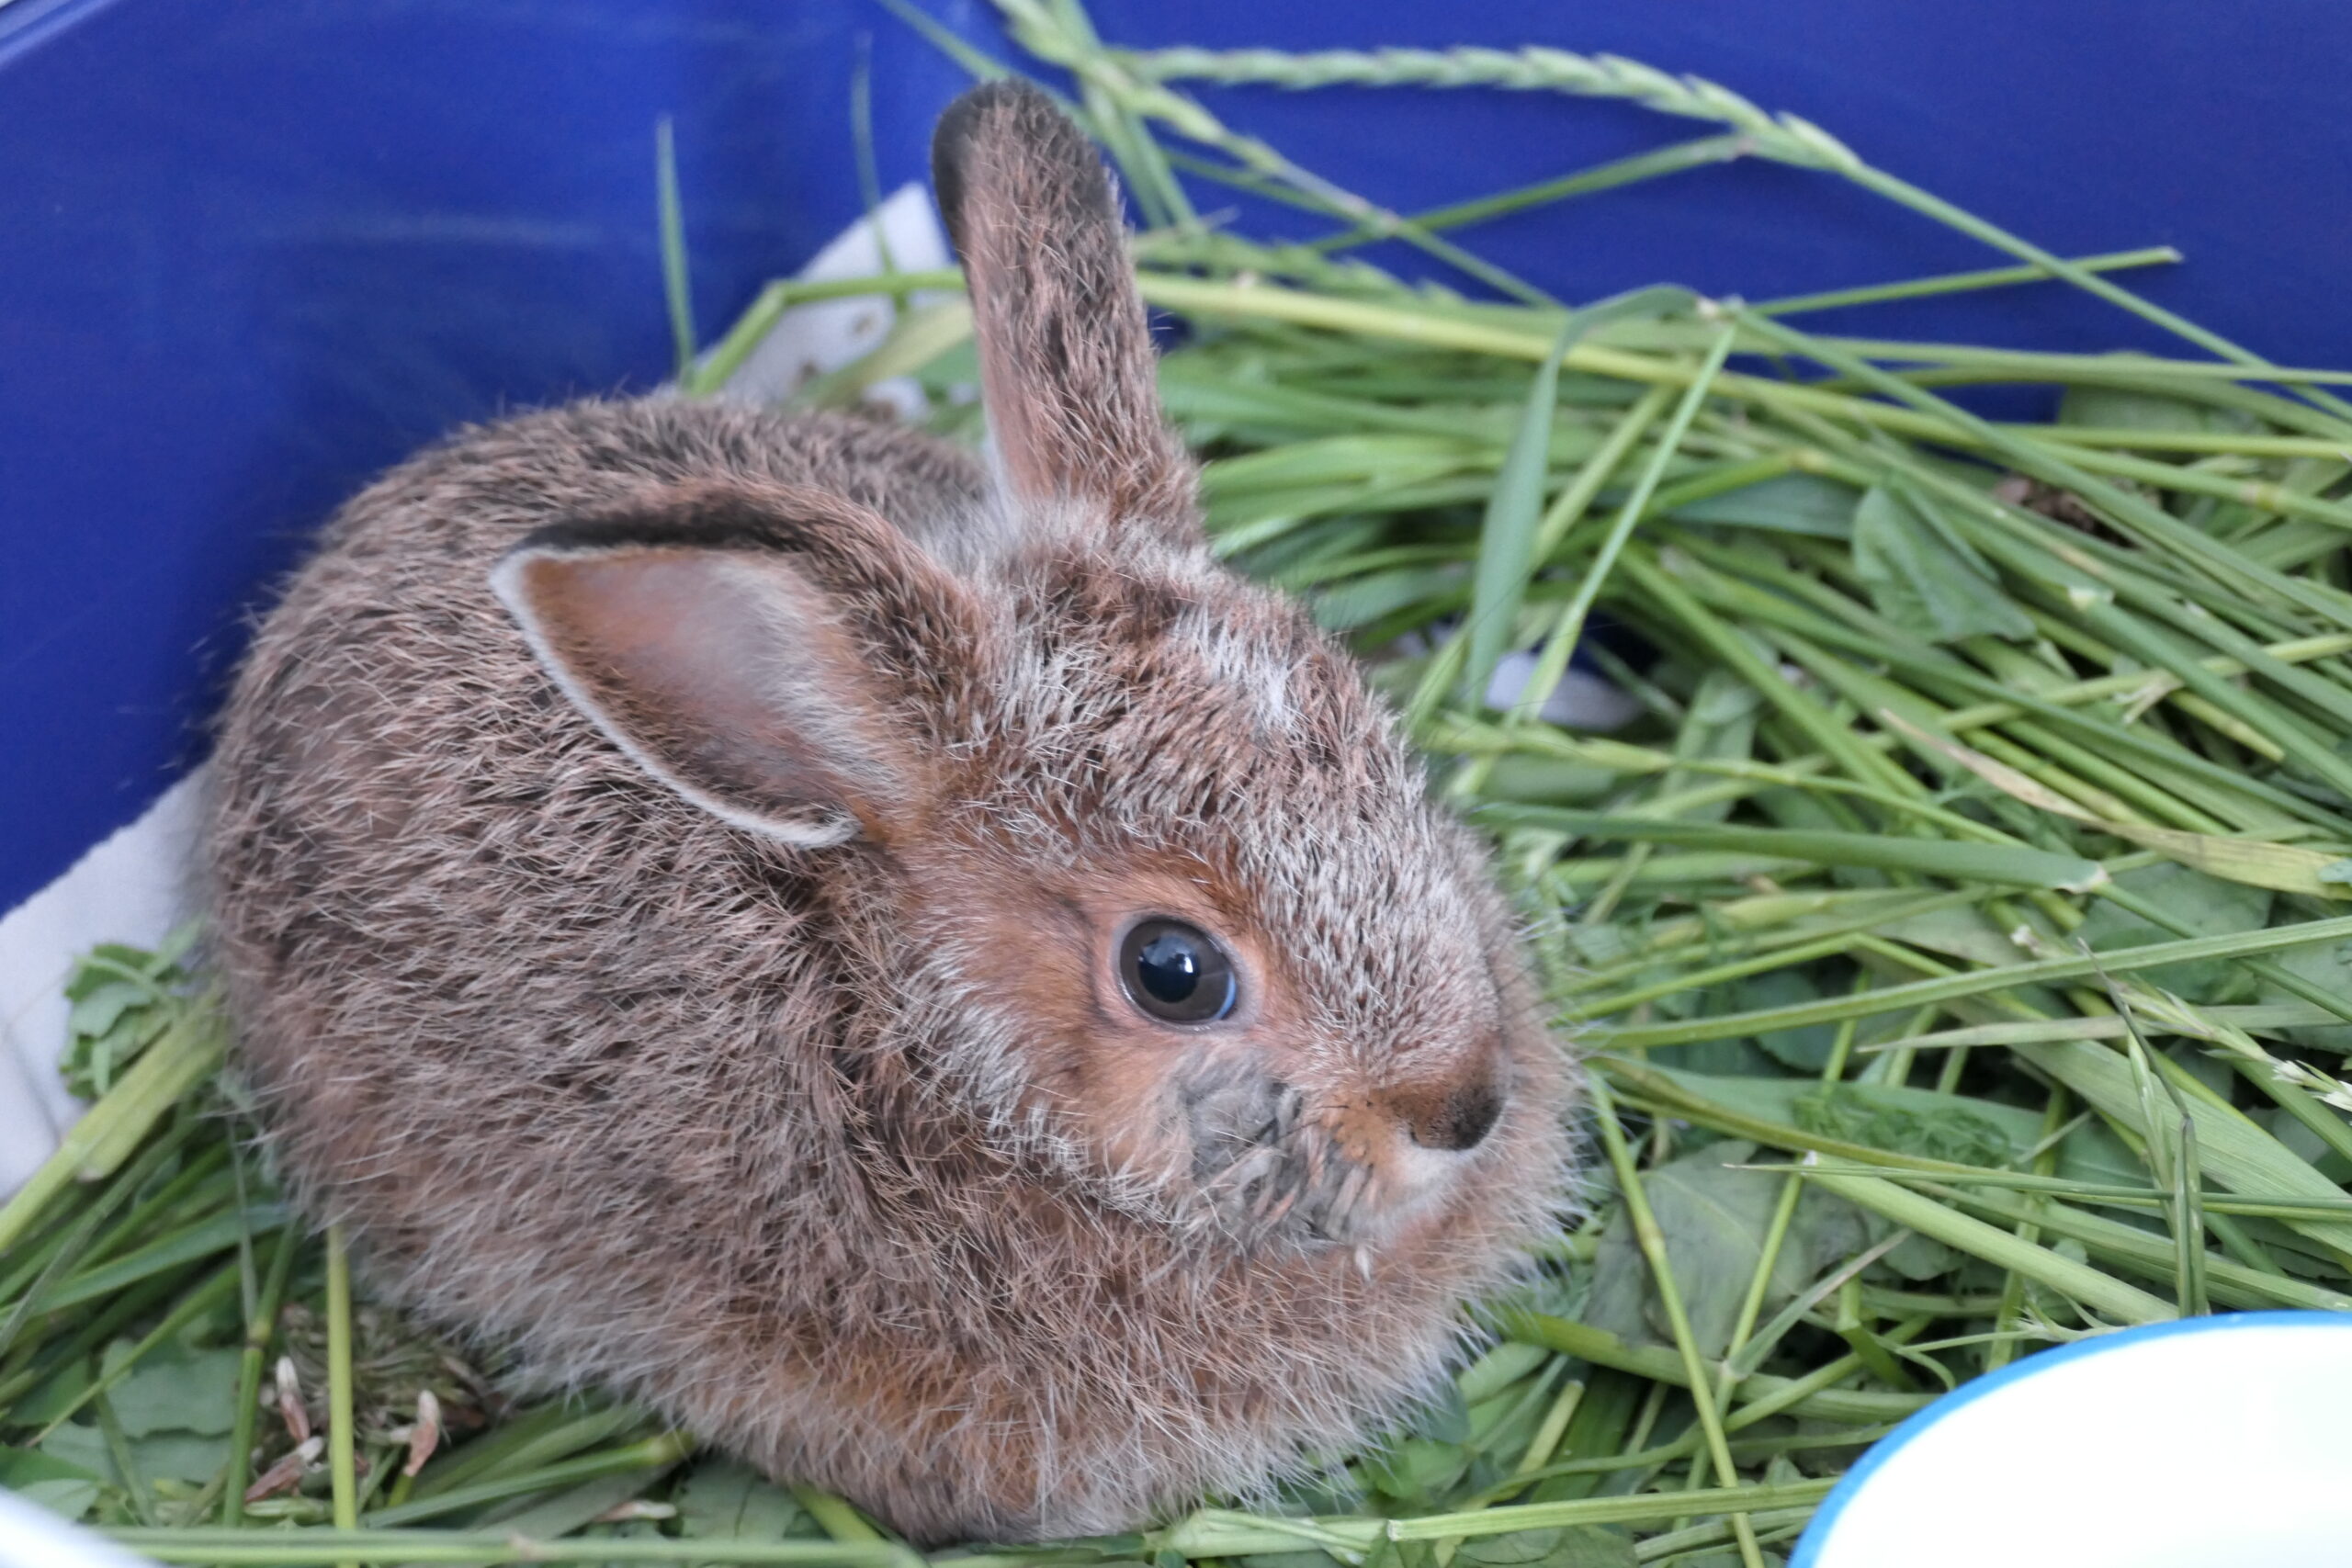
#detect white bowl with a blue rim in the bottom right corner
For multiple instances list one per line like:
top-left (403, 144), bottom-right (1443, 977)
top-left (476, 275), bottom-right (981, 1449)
top-left (1790, 1312), bottom-right (2352, 1568)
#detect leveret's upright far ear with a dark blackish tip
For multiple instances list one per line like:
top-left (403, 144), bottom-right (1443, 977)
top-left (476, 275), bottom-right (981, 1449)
top-left (932, 80), bottom-right (1193, 540)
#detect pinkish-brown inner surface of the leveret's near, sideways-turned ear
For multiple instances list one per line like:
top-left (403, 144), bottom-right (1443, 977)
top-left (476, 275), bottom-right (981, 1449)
top-left (513, 547), bottom-right (891, 844)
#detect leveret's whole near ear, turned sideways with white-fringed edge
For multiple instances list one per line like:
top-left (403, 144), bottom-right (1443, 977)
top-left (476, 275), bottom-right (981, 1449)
top-left (492, 489), bottom-right (981, 849)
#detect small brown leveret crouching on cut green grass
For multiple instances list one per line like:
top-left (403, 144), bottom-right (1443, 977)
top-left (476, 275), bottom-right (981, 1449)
top-left (209, 83), bottom-right (1571, 1542)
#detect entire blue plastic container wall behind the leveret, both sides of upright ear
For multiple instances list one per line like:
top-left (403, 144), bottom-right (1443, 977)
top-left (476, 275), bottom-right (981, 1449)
top-left (0, 0), bottom-right (2352, 908)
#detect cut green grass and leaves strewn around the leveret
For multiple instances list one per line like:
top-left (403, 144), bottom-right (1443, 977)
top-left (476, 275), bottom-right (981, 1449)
top-left (0, 0), bottom-right (2352, 1568)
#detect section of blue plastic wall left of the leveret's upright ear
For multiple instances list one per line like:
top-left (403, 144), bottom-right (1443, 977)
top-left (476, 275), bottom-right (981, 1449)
top-left (0, 0), bottom-right (983, 909)
